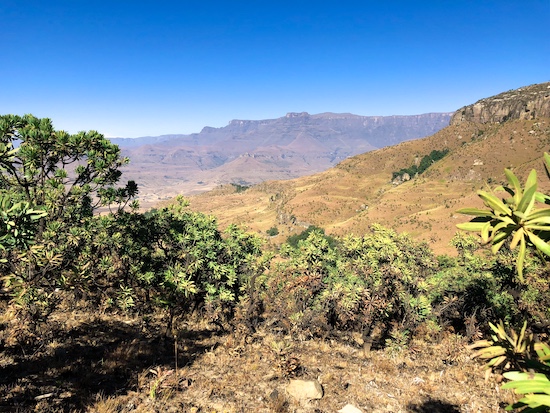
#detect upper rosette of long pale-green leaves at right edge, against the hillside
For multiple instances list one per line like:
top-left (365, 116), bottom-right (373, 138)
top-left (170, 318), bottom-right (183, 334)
top-left (458, 153), bottom-right (550, 325)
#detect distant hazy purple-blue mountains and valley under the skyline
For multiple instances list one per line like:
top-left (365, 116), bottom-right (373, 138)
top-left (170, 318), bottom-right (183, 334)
top-left (112, 112), bottom-right (452, 206)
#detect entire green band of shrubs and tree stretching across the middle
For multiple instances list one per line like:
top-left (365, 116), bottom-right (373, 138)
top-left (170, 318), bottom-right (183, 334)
top-left (0, 116), bottom-right (550, 352)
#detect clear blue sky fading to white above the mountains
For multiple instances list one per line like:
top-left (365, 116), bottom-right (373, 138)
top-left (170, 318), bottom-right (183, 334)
top-left (0, 0), bottom-right (550, 137)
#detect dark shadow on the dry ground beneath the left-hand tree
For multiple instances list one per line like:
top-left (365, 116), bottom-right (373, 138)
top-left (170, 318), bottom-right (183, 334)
top-left (0, 314), bottom-right (219, 412)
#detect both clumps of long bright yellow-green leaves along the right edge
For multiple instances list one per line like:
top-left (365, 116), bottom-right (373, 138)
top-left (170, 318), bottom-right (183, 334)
top-left (459, 153), bottom-right (550, 412)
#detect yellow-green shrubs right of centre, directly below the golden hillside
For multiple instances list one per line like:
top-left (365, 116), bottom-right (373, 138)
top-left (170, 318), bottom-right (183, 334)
top-left (256, 224), bottom-right (550, 345)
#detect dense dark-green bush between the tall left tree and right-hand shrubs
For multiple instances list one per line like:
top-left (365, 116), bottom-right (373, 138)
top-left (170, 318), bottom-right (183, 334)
top-left (64, 197), bottom-right (261, 323)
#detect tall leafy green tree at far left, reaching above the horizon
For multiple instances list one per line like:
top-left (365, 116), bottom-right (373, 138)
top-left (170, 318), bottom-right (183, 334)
top-left (0, 115), bottom-right (137, 301)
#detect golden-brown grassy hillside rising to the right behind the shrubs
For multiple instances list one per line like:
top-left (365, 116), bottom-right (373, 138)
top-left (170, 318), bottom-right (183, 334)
top-left (191, 84), bottom-right (550, 253)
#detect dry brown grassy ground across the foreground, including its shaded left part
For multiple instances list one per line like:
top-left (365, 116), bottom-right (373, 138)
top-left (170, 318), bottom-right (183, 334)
top-left (0, 300), bottom-right (513, 413)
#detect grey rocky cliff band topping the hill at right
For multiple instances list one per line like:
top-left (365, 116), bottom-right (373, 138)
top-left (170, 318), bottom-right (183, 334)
top-left (451, 82), bottom-right (550, 125)
